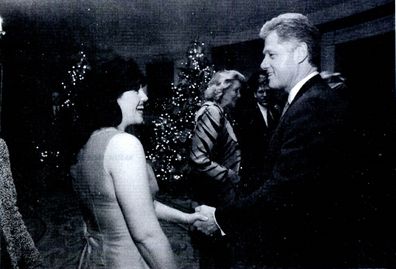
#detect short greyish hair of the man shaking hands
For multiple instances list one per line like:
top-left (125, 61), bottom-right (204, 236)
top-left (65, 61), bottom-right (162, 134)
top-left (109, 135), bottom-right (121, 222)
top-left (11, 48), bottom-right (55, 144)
top-left (259, 13), bottom-right (320, 66)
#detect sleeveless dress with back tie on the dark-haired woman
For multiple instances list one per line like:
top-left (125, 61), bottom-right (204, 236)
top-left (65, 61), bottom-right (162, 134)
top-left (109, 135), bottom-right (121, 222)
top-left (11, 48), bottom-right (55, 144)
top-left (71, 128), bottom-right (149, 269)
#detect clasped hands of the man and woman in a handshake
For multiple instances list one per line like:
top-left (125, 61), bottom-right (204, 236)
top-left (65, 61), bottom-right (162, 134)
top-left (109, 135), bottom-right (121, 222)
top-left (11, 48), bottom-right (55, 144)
top-left (187, 205), bottom-right (219, 236)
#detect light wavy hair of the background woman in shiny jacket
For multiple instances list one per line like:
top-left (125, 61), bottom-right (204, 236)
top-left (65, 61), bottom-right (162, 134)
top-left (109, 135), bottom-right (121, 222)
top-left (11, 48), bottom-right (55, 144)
top-left (204, 70), bottom-right (246, 103)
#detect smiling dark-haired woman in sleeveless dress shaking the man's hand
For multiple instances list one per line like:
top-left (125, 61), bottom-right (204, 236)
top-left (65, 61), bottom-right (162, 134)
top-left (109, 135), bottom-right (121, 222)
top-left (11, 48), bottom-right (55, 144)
top-left (71, 58), bottom-right (205, 269)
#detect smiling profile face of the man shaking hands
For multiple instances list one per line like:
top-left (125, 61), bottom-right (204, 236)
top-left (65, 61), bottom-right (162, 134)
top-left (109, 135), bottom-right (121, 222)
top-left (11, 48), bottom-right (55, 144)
top-left (261, 31), bottom-right (298, 92)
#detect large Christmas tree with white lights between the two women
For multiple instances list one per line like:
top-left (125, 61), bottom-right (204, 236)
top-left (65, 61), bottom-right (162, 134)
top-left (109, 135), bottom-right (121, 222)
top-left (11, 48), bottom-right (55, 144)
top-left (147, 41), bottom-right (215, 182)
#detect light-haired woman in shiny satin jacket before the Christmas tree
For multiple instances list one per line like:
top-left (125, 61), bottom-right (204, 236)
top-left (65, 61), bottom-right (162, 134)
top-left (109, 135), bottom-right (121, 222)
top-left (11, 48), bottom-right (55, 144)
top-left (190, 70), bottom-right (245, 268)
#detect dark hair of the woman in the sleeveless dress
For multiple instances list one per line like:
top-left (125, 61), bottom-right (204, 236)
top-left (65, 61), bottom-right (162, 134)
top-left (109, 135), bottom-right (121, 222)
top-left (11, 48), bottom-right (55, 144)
top-left (74, 57), bottom-right (146, 157)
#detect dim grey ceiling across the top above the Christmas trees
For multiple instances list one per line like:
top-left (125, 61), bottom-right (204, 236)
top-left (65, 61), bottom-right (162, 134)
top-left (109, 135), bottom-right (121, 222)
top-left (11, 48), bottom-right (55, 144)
top-left (0, 0), bottom-right (390, 64)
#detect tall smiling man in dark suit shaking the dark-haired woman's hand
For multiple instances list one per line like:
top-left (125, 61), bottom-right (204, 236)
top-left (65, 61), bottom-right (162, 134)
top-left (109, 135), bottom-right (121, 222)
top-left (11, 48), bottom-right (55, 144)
top-left (194, 13), bottom-right (359, 268)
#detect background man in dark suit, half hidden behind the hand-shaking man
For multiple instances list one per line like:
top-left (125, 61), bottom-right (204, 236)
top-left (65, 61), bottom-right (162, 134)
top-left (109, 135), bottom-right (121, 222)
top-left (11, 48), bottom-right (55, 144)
top-left (235, 69), bottom-right (285, 193)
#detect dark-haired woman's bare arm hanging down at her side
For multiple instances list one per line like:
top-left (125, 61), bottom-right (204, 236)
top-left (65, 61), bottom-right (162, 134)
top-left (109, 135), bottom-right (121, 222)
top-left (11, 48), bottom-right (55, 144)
top-left (104, 134), bottom-right (176, 269)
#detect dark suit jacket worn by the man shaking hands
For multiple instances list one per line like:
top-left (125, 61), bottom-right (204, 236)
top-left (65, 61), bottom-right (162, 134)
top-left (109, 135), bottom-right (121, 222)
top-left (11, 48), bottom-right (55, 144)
top-left (216, 75), bottom-right (358, 267)
